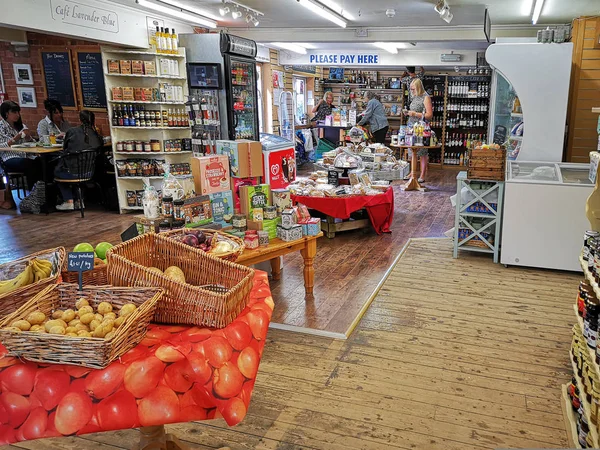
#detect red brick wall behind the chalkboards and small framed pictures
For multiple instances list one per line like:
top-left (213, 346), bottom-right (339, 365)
top-left (0, 33), bottom-right (110, 135)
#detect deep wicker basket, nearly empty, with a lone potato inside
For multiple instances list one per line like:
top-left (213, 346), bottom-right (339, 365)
top-left (107, 233), bottom-right (254, 328)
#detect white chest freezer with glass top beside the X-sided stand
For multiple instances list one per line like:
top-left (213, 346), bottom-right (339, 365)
top-left (500, 161), bottom-right (594, 272)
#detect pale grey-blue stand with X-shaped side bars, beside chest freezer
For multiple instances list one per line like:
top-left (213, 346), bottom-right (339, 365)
top-left (452, 171), bottom-right (504, 263)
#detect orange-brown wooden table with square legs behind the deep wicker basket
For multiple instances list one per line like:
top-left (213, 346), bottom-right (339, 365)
top-left (236, 233), bottom-right (323, 295)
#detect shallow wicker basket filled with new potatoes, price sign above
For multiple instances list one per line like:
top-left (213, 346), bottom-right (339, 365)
top-left (0, 283), bottom-right (163, 369)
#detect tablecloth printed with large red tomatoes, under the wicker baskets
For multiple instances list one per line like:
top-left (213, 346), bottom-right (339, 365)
top-left (0, 271), bottom-right (273, 445)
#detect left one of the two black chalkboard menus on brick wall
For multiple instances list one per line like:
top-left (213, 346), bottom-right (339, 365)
top-left (42, 51), bottom-right (76, 108)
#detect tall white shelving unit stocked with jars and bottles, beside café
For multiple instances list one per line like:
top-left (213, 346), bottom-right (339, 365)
top-left (102, 47), bottom-right (194, 213)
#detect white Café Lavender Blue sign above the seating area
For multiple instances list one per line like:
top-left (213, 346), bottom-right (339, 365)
top-left (50, 0), bottom-right (119, 33)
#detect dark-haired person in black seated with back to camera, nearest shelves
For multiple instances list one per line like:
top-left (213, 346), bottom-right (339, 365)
top-left (54, 109), bottom-right (103, 211)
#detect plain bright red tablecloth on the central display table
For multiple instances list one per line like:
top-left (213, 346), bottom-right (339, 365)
top-left (292, 186), bottom-right (394, 234)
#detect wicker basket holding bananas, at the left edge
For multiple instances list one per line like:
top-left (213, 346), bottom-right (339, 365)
top-left (0, 247), bottom-right (66, 319)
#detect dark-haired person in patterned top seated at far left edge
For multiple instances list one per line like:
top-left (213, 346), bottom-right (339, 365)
top-left (0, 100), bottom-right (42, 208)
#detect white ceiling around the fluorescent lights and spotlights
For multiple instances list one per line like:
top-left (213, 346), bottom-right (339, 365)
top-left (126, 0), bottom-right (600, 28)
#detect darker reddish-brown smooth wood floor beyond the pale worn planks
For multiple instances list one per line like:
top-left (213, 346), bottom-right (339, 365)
top-left (0, 170), bottom-right (458, 333)
